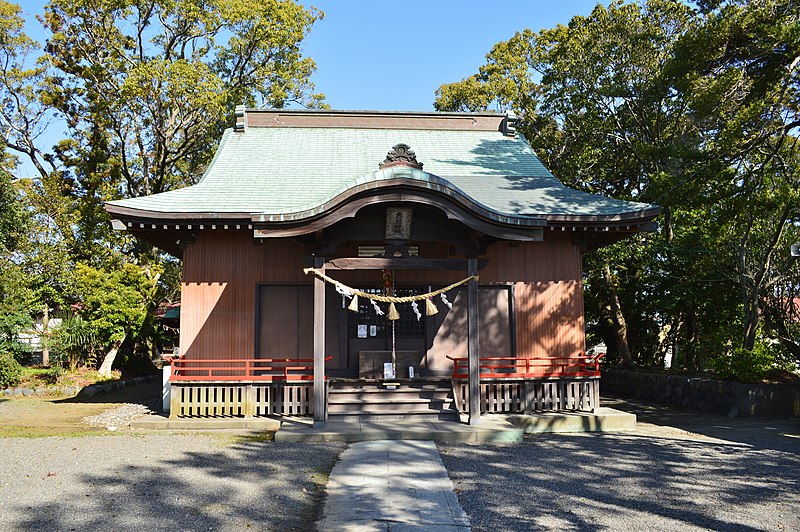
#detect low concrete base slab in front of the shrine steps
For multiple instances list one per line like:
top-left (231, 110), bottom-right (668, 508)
top-left (275, 408), bottom-right (636, 443)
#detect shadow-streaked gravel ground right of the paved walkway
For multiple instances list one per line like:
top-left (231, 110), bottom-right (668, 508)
top-left (439, 409), bottom-right (800, 531)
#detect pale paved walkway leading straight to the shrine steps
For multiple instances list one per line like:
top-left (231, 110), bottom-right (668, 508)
top-left (317, 440), bottom-right (471, 532)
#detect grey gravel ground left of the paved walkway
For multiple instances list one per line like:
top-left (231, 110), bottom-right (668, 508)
top-left (0, 433), bottom-right (344, 531)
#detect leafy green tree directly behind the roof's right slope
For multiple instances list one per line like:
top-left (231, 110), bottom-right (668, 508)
top-left (435, 0), bottom-right (697, 364)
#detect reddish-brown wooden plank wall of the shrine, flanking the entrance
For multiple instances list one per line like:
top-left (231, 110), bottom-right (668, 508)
top-left (181, 230), bottom-right (585, 362)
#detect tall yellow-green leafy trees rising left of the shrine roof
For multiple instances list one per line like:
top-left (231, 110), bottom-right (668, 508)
top-left (0, 0), bottom-right (324, 370)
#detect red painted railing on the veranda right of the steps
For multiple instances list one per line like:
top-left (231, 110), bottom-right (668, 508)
top-left (447, 353), bottom-right (606, 379)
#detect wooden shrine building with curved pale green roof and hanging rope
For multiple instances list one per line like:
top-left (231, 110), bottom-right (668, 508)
top-left (106, 108), bottom-right (659, 423)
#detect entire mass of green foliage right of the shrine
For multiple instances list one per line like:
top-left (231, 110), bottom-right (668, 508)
top-left (435, 0), bottom-right (800, 371)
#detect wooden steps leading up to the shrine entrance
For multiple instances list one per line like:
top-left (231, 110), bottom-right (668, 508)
top-left (328, 379), bottom-right (458, 421)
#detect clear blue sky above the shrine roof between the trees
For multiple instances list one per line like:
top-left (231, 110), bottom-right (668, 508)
top-left (18, 0), bottom-right (597, 177)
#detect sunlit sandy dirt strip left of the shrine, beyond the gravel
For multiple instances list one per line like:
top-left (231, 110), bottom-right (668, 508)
top-left (0, 380), bottom-right (161, 438)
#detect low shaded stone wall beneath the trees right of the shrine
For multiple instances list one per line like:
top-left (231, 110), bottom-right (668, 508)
top-left (600, 368), bottom-right (800, 417)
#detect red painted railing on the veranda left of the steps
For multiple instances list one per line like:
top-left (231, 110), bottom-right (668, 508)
top-left (167, 357), bottom-right (333, 382)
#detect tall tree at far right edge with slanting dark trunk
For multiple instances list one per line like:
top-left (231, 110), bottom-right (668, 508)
top-left (674, 0), bottom-right (800, 350)
